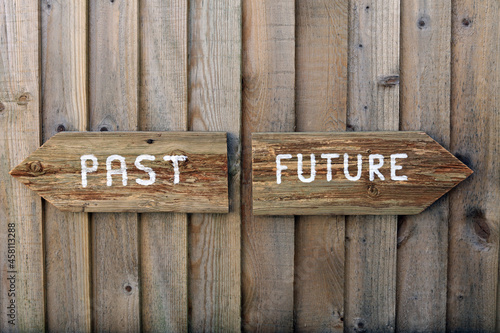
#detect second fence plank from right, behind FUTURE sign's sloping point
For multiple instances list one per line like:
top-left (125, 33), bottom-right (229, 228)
top-left (396, 0), bottom-right (451, 332)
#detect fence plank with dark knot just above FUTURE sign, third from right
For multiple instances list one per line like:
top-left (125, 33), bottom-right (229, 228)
top-left (345, 0), bottom-right (400, 332)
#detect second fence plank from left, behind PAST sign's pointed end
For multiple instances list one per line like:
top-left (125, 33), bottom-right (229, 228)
top-left (40, 1), bottom-right (92, 332)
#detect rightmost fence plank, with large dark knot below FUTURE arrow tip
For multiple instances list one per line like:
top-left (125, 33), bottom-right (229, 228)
top-left (447, 0), bottom-right (500, 332)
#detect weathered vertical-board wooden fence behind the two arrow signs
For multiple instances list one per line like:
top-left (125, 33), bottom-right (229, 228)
top-left (0, 0), bottom-right (500, 332)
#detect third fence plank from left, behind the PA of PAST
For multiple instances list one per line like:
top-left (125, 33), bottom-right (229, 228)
top-left (89, 0), bottom-right (140, 332)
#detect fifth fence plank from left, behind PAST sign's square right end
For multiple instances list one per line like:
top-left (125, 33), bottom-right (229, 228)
top-left (189, 0), bottom-right (241, 332)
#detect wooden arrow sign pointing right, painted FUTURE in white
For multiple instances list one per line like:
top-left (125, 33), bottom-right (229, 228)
top-left (252, 132), bottom-right (472, 215)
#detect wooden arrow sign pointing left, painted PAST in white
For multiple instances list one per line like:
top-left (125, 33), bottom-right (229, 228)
top-left (10, 132), bottom-right (229, 213)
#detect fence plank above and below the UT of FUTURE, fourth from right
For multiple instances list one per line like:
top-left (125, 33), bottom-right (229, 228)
top-left (294, 0), bottom-right (348, 332)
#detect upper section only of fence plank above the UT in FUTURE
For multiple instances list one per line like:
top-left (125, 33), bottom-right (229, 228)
top-left (295, 0), bottom-right (349, 132)
